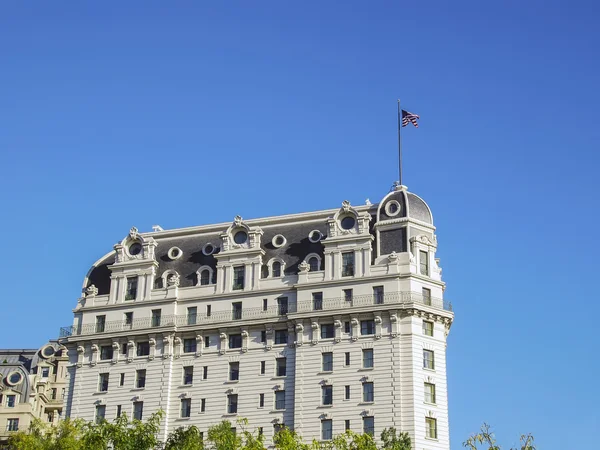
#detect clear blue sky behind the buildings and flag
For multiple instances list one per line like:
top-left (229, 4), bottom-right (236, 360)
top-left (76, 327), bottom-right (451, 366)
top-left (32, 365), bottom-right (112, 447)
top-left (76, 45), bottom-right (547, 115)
top-left (0, 0), bottom-right (600, 450)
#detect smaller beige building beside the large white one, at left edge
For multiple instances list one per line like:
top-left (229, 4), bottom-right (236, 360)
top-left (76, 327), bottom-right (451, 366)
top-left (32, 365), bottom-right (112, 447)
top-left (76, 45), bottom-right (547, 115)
top-left (0, 341), bottom-right (68, 446)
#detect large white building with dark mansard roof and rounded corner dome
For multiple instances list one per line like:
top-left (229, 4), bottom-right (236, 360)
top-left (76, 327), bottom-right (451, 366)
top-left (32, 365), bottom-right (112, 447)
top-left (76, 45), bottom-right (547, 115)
top-left (61, 186), bottom-right (453, 450)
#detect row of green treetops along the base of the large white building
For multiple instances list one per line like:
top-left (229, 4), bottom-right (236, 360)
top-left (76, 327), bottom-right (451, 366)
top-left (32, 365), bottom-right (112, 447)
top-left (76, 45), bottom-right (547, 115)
top-left (8, 411), bottom-right (410, 450)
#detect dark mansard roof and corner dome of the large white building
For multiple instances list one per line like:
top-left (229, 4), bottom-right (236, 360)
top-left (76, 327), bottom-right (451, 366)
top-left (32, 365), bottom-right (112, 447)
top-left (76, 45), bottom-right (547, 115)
top-left (83, 186), bottom-right (433, 295)
